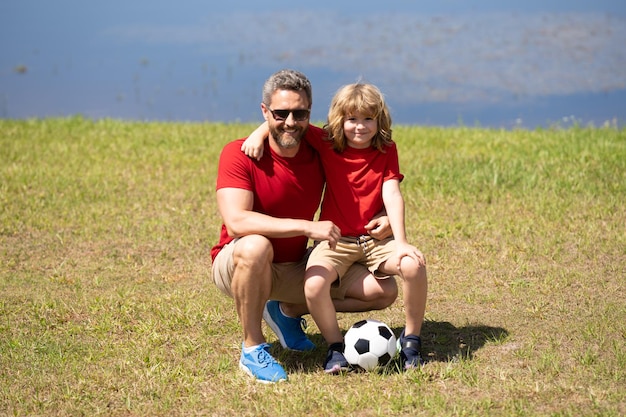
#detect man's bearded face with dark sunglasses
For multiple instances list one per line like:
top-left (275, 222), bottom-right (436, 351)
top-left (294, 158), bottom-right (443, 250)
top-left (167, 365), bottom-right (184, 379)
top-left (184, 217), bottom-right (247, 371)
top-left (261, 90), bottom-right (310, 152)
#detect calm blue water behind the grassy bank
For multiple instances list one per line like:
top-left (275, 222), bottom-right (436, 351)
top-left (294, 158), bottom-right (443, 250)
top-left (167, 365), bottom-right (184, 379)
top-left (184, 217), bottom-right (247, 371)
top-left (0, 0), bottom-right (626, 128)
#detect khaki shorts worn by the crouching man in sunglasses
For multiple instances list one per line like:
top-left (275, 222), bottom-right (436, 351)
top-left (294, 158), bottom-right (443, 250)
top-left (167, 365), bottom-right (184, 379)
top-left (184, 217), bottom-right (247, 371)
top-left (211, 239), bottom-right (369, 304)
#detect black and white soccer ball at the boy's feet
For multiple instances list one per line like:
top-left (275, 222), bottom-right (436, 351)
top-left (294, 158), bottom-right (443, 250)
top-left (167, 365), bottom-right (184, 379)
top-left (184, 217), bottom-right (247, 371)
top-left (343, 319), bottom-right (397, 371)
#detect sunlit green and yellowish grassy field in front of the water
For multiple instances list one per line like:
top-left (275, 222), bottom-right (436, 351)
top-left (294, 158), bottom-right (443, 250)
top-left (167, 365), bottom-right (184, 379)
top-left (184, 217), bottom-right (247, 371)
top-left (0, 117), bottom-right (626, 417)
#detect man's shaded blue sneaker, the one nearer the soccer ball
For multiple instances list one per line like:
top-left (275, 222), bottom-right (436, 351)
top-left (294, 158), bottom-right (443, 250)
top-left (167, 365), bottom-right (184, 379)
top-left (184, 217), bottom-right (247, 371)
top-left (263, 300), bottom-right (315, 352)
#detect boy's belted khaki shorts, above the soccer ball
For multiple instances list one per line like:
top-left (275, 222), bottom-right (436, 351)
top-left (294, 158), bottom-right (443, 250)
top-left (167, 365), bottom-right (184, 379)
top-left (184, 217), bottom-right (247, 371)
top-left (308, 235), bottom-right (396, 280)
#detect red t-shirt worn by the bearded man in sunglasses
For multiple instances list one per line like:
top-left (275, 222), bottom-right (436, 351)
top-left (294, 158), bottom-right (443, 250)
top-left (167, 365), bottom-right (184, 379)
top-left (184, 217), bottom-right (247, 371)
top-left (211, 126), bottom-right (325, 263)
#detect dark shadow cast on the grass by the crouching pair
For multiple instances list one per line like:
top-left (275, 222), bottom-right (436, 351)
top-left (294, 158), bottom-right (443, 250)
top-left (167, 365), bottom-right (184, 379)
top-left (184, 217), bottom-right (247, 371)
top-left (271, 321), bottom-right (509, 373)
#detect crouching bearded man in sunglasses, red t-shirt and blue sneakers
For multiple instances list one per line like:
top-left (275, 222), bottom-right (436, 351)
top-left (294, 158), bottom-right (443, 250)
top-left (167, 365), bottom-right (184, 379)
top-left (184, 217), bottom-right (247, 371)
top-left (211, 70), bottom-right (398, 383)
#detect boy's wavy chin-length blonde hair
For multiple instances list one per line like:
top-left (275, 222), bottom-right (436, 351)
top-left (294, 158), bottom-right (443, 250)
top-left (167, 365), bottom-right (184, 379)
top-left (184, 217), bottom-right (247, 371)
top-left (324, 83), bottom-right (392, 152)
